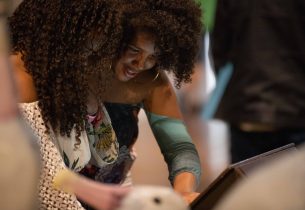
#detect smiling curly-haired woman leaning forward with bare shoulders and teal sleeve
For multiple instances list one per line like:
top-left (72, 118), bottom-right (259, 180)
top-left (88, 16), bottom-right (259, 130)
top-left (10, 0), bottom-right (201, 208)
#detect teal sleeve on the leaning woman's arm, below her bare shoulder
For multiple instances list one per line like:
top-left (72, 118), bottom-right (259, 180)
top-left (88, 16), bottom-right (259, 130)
top-left (146, 112), bottom-right (201, 185)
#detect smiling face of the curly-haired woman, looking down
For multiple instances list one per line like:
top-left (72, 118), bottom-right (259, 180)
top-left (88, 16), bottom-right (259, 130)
top-left (115, 32), bottom-right (157, 82)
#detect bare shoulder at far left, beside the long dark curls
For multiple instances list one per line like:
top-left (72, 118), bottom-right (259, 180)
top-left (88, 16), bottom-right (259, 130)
top-left (10, 54), bottom-right (37, 103)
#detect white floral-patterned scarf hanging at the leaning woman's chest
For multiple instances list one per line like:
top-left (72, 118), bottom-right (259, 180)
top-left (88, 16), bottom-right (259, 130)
top-left (51, 104), bottom-right (119, 171)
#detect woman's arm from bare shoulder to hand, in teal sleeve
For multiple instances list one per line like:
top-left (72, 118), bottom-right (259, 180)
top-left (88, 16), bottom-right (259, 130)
top-left (144, 74), bottom-right (201, 203)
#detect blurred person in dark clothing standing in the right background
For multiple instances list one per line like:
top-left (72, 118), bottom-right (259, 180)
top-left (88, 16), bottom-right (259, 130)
top-left (211, 0), bottom-right (305, 163)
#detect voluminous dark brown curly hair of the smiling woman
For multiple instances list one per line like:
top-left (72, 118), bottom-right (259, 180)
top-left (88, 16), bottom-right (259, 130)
top-left (9, 0), bottom-right (202, 139)
